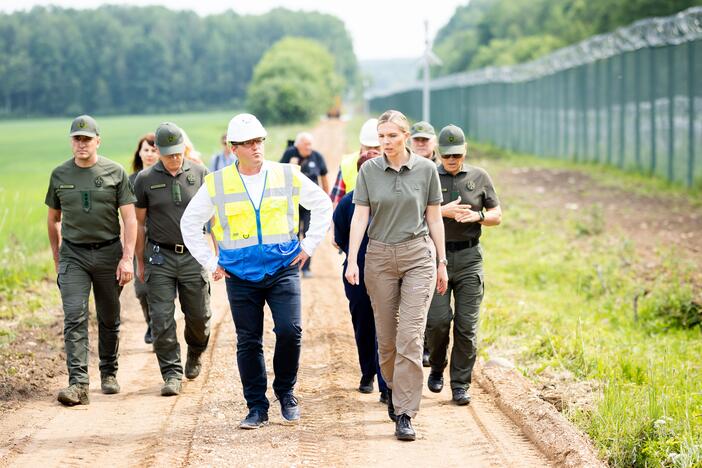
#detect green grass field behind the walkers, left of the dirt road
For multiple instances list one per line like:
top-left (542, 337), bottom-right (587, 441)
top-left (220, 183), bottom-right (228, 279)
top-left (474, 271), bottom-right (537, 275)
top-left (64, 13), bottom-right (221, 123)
top-left (0, 112), bottom-right (309, 298)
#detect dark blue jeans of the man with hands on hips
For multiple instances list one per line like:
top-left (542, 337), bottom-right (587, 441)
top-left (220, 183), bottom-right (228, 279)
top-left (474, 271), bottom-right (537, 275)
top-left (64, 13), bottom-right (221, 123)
top-left (226, 266), bottom-right (302, 411)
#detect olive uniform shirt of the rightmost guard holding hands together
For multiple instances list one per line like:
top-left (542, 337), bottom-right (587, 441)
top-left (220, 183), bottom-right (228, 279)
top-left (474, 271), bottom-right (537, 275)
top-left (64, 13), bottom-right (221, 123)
top-left (439, 164), bottom-right (500, 242)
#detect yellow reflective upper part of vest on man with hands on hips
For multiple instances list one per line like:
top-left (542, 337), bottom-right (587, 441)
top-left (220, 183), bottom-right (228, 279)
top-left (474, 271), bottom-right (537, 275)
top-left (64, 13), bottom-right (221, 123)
top-left (205, 162), bottom-right (301, 250)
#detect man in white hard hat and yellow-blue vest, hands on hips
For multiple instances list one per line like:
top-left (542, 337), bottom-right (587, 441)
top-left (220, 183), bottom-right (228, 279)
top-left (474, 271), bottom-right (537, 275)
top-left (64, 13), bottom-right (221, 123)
top-left (180, 114), bottom-right (332, 429)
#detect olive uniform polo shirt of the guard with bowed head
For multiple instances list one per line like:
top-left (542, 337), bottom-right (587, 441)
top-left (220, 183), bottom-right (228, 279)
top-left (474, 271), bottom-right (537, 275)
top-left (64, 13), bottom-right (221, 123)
top-left (134, 159), bottom-right (207, 244)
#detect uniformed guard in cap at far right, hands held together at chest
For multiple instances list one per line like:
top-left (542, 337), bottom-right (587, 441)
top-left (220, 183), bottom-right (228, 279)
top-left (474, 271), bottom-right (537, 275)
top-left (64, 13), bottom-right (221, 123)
top-left (426, 125), bottom-right (502, 406)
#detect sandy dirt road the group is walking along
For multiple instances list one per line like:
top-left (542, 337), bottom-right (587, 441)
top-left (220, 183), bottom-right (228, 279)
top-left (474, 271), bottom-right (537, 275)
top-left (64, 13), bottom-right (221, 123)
top-left (0, 122), bottom-right (549, 467)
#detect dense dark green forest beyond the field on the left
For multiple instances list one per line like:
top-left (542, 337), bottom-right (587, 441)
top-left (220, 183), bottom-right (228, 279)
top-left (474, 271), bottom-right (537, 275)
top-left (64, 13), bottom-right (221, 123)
top-left (0, 6), bottom-right (358, 116)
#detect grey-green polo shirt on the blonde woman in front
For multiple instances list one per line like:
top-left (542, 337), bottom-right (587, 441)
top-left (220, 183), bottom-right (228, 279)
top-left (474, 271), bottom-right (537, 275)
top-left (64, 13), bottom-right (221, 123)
top-left (353, 152), bottom-right (441, 244)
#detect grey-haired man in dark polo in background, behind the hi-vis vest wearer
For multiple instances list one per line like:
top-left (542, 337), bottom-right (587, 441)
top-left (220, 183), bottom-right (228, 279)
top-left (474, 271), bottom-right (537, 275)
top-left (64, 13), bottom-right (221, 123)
top-left (280, 132), bottom-right (329, 278)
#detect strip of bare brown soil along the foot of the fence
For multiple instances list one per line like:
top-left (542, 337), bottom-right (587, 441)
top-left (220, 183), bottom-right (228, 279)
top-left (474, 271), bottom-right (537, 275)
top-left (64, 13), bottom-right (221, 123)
top-left (496, 167), bottom-right (702, 284)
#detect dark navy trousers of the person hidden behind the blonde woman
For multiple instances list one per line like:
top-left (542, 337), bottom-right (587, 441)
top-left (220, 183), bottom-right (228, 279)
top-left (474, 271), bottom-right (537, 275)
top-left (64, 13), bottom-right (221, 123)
top-left (343, 272), bottom-right (388, 392)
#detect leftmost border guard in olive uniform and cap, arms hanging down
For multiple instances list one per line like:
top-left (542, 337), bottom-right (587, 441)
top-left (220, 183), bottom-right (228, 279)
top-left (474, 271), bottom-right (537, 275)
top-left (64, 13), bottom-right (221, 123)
top-left (45, 115), bottom-right (136, 406)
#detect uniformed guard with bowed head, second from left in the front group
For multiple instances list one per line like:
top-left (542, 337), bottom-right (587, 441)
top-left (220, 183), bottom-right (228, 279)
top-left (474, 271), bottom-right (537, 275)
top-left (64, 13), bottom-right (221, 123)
top-left (134, 122), bottom-right (212, 396)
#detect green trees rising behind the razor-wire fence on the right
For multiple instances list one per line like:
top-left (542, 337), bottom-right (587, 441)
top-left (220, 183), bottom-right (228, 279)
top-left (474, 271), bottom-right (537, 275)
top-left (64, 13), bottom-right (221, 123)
top-left (434, 0), bottom-right (702, 75)
